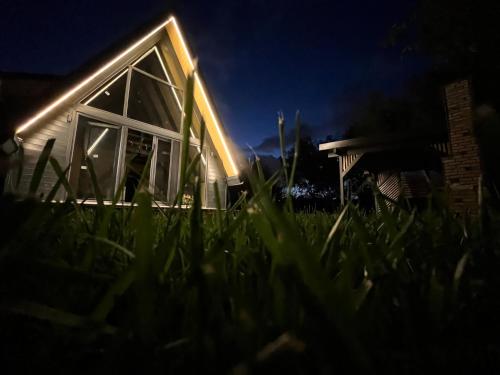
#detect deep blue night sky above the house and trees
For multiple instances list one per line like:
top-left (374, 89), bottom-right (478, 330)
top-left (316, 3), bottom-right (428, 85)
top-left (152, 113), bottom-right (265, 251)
top-left (0, 0), bottom-right (422, 153)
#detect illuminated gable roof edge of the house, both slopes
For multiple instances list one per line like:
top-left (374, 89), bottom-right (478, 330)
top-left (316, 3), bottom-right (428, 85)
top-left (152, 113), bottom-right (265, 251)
top-left (11, 16), bottom-right (238, 177)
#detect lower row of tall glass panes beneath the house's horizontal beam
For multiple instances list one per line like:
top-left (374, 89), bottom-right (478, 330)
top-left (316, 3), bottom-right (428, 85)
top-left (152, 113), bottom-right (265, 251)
top-left (70, 115), bottom-right (213, 206)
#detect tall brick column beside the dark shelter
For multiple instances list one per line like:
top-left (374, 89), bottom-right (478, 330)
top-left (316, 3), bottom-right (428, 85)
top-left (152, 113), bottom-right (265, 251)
top-left (443, 80), bottom-right (481, 216)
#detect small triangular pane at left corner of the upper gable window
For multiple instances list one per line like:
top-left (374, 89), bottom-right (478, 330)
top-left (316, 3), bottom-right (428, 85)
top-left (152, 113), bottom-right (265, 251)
top-left (83, 70), bottom-right (127, 115)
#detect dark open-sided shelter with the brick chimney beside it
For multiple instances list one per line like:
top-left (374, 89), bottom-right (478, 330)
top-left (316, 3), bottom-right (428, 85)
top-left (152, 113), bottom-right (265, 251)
top-left (319, 80), bottom-right (481, 214)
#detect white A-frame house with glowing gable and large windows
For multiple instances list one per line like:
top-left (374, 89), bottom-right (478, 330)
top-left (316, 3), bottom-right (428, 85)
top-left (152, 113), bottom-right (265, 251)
top-left (0, 17), bottom-right (238, 208)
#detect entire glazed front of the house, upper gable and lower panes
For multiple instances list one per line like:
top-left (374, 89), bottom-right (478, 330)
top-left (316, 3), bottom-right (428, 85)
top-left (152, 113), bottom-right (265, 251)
top-left (74, 42), bottom-right (217, 204)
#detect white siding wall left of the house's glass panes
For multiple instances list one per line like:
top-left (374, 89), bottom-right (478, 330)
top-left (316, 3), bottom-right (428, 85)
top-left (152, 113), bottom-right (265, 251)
top-left (11, 110), bottom-right (73, 199)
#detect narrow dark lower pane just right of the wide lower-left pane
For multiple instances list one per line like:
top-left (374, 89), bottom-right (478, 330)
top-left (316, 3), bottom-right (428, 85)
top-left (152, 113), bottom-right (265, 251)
top-left (125, 130), bottom-right (153, 202)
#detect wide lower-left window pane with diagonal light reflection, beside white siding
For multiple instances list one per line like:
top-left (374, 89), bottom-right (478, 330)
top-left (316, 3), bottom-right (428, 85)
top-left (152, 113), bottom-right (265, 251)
top-left (70, 116), bottom-right (120, 200)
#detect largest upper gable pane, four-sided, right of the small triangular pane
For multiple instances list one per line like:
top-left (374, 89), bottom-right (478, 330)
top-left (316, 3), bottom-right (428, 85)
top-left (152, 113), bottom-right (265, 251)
top-left (127, 71), bottom-right (181, 132)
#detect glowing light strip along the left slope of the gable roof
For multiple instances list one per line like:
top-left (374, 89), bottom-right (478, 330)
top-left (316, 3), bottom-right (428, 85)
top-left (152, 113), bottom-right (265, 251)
top-left (16, 17), bottom-right (175, 134)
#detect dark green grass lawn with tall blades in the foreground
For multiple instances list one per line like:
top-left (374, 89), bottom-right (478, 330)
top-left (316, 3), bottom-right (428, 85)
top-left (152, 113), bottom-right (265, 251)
top-left (0, 72), bottom-right (500, 374)
